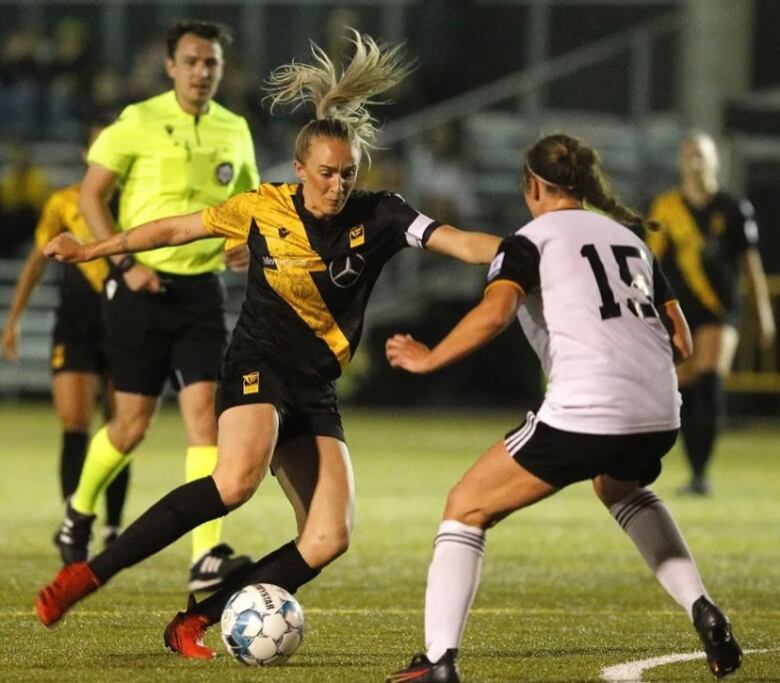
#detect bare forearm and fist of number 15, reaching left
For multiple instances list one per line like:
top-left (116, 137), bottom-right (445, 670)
top-left (385, 282), bottom-right (525, 374)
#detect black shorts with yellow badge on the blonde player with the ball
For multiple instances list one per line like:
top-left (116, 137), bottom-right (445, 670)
top-left (216, 361), bottom-right (345, 444)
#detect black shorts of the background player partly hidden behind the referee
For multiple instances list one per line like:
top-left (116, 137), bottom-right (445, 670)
top-left (49, 288), bottom-right (108, 375)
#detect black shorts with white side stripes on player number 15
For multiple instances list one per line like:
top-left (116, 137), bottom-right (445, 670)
top-left (504, 413), bottom-right (678, 488)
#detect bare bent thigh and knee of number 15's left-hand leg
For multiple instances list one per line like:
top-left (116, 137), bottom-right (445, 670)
top-left (444, 439), bottom-right (558, 529)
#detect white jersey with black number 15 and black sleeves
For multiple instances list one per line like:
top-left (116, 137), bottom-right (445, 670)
top-left (488, 210), bottom-right (681, 434)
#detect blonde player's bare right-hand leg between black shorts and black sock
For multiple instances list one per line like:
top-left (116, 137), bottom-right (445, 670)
top-left (273, 436), bottom-right (355, 568)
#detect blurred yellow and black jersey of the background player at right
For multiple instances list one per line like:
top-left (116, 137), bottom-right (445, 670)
top-left (647, 190), bottom-right (758, 325)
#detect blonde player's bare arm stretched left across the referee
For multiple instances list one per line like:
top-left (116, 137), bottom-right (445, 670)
top-left (43, 211), bottom-right (212, 263)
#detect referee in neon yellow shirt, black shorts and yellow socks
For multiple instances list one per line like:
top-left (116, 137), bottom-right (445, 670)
top-left (58, 22), bottom-right (259, 590)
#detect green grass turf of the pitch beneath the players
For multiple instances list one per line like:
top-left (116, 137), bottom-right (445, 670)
top-left (0, 403), bottom-right (780, 683)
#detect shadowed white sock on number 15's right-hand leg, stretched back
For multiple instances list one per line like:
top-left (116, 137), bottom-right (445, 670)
top-left (609, 488), bottom-right (709, 617)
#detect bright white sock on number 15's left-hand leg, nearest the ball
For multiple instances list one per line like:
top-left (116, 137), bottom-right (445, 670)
top-left (425, 520), bottom-right (485, 662)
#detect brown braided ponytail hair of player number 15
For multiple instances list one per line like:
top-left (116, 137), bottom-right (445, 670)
top-left (525, 133), bottom-right (658, 232)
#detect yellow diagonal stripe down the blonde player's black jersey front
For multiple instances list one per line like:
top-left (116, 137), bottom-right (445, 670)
top-left (260, 188), bottom-right (351, 370)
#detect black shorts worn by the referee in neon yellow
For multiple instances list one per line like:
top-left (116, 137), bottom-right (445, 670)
top-left (103, 272), bottom-right (227, 396)
